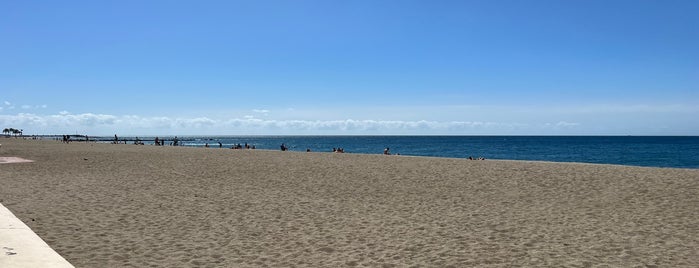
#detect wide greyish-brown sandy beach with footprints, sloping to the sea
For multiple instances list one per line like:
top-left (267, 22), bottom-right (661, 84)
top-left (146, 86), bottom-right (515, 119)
top-left (0, 138), bottom-right (699, 267)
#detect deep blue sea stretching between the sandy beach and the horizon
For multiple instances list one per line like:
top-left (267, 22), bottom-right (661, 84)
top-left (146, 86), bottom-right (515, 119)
top-left (95, 136), bottom-right (699, 169)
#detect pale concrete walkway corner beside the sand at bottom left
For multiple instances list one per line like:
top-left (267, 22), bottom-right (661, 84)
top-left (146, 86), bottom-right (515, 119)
top-left (0, 204), bottom-right (74, 268)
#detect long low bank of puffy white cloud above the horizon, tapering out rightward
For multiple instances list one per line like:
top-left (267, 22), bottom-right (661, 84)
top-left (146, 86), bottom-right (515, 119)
top-left (0, 111), bottom-right (522, 135)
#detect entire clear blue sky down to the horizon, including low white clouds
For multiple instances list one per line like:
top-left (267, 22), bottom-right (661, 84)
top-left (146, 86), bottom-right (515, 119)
top-left (0, 0), bottom-right (699, 135)
